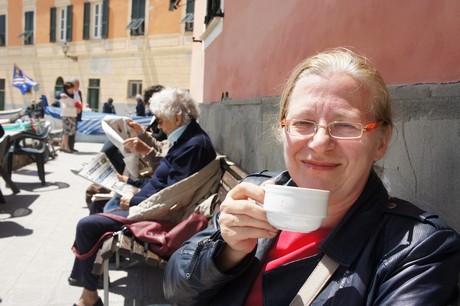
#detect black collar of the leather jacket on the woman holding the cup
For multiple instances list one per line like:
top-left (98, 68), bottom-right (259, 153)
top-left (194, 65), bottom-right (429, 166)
top-left (275, 171), bottom-right (388, 267)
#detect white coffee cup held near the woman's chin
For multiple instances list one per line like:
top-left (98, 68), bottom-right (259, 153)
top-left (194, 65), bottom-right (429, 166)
top-left (263, 185), bottom-right (329, 233)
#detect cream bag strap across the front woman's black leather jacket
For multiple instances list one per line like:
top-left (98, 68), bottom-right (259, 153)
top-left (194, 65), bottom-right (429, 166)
top-left (289, 254), bottom-right (339, 306)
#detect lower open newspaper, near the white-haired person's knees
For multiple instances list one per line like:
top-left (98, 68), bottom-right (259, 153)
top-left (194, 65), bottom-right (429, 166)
top-left (76, 152), bottom-right (138, 196)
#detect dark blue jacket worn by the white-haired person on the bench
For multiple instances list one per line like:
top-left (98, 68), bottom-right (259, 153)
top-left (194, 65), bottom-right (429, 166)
top-left (128, 119), bottom-right (217, 206)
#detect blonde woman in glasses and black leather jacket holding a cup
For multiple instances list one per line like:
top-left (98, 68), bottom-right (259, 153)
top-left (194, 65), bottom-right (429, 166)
top-left (164, 48), bottom-right (460, 305)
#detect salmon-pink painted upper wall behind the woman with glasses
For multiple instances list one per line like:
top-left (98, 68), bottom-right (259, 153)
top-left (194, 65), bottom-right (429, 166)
top-left (199, 0), bottom-right (460, 102)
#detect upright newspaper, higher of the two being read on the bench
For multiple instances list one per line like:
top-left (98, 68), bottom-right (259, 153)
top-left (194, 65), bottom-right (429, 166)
top-left (101, 115), bottom-right (139, 179)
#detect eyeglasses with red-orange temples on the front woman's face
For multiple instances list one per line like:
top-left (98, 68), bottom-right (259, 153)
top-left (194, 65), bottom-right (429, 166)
top-left (281, 119), bottom-right (383, 139)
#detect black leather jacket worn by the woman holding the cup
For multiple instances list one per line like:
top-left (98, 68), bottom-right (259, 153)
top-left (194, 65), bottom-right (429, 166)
top-left (163, 172), bottom-right (460, 306)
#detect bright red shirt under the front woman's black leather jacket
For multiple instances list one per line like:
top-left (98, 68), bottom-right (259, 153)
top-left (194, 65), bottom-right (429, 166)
top-left (245, 229), bottom-right (331, 306)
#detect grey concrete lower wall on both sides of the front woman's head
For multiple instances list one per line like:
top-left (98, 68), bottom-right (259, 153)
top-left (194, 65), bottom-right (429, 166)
top-left (200, 83), bottom-right (460, 231)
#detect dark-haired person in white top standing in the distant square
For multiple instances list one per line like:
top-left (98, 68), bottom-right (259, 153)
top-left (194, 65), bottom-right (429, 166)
top-left (59, 82), bottom-right (77, 153)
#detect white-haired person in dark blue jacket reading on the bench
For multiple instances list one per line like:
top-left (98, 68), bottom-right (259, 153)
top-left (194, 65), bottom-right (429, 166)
top-left (68, 88), bottom-right (217, 305)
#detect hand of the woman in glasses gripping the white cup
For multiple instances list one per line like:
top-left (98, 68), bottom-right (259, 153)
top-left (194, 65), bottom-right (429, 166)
top-left (216, 183), bottom-right (277, 272)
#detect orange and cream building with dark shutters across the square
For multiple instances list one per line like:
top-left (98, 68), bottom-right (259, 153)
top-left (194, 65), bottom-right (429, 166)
top-left (0, 0), bottom-right (194, 114)
